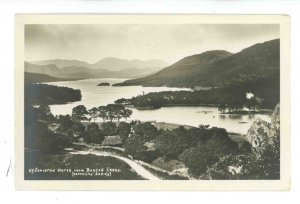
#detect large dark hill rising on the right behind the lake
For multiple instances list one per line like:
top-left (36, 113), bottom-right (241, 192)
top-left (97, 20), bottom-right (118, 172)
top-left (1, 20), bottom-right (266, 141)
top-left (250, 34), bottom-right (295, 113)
top-left (115, 39), bottom-right (280, 87)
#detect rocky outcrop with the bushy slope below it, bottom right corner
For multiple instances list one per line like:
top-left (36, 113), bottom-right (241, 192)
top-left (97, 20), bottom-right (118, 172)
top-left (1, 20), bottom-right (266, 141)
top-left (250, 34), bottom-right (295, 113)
top-left (202, 104), bottom-right (280, 180)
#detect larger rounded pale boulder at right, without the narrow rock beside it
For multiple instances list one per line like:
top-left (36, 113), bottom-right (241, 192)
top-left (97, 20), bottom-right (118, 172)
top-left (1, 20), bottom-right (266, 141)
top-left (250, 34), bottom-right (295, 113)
top-left (246, 118), bottom-right (271, 148)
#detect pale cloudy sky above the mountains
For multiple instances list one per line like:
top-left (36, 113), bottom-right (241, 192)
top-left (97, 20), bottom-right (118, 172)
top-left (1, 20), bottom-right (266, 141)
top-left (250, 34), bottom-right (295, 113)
top-left (25, 24), bottom-right (280, 64)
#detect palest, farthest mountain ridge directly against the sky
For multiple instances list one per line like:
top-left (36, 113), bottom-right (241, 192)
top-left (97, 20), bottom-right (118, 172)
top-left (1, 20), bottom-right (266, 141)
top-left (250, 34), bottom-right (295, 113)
top-left (30, 57), bottom-right (168, 71)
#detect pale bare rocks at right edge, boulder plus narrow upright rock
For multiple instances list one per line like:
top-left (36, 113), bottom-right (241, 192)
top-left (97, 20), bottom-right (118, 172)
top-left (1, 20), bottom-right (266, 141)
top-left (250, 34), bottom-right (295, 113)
top-left (246, 104), bottom-right (280, 149)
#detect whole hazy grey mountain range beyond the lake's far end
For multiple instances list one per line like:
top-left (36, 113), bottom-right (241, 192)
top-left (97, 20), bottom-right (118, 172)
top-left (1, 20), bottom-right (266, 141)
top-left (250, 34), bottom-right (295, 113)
top-left (24, 58), bottom-right (167, 79)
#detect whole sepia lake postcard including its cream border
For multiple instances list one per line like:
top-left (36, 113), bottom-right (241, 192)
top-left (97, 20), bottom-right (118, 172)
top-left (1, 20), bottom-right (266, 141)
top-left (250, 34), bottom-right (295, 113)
top-left (16, 15), bottom-right (289, 190)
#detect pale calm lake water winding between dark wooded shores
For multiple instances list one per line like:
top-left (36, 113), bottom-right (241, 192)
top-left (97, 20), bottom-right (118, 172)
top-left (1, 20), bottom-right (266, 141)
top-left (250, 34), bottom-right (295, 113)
top-left (47, 79), bottom-right (271, 134)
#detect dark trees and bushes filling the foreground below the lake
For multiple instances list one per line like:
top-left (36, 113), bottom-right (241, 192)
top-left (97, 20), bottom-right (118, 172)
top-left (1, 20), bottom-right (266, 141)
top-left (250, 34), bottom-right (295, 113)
top-left (25, 101), bottom-right (279, 179)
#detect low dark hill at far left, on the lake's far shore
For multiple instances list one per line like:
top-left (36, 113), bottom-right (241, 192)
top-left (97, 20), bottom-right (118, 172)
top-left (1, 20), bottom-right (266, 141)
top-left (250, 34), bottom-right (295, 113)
top-left (24, 72), bottom-right (80, 84)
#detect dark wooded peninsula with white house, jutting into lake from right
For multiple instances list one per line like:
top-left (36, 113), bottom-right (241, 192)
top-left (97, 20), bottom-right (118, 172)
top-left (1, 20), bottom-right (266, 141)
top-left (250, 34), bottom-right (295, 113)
top-left (115, 73), bottom-right (280, 113)
